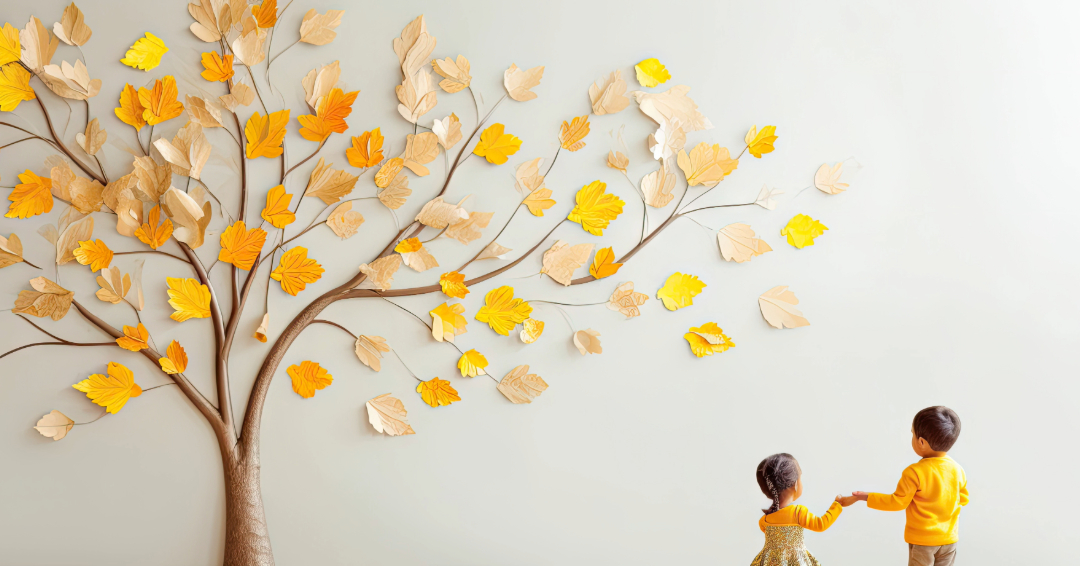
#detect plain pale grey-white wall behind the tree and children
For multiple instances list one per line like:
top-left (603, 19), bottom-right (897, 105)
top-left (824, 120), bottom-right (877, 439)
top-left (0, 0), bottom-right (1080, 566)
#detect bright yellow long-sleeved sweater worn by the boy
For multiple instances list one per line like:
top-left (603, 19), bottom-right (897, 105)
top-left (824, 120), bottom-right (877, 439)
top-left (866, 456), bottom-right (968, 547)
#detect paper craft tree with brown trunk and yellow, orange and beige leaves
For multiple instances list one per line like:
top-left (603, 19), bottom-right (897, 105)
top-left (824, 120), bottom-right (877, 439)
top-left (0, 0), bottom-right (847, 565)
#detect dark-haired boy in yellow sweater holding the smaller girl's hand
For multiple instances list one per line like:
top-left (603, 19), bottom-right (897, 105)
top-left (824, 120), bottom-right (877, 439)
top-left (851, 406), bottom-right (968, 566)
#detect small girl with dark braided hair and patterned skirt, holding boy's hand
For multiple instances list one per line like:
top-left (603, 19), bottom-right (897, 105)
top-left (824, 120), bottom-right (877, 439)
top-left (751, 454), bottom-right (855, 566)
